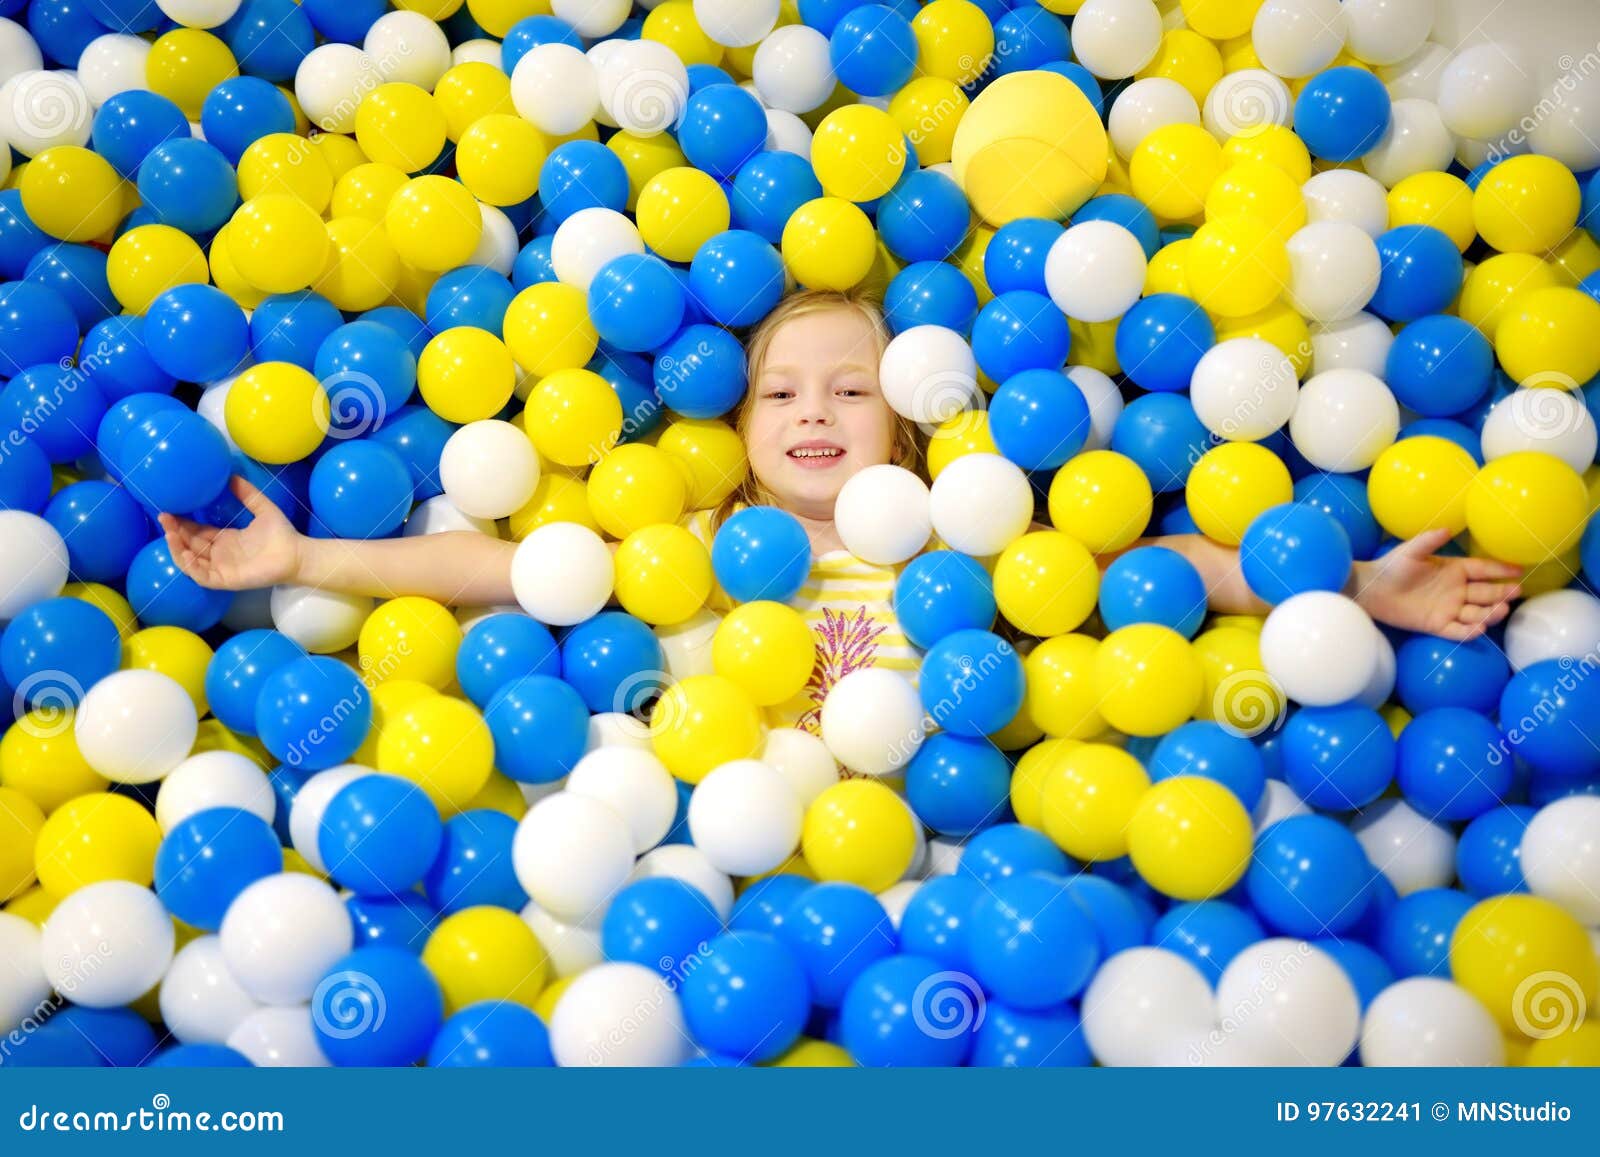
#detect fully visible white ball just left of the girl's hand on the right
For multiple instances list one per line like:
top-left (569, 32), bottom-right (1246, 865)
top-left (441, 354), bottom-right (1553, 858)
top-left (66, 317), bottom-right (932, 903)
top-left (1261, 591), bottom-right (1378, 707)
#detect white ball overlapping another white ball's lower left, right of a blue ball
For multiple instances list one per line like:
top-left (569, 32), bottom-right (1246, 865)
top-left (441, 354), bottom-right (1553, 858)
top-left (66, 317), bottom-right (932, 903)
top-left (510, 792), bottom-right (634, 922)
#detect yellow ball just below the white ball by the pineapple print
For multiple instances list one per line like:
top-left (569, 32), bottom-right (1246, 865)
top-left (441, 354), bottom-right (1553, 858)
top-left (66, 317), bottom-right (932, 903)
top-left (800, 779), bottom-right (917, 893)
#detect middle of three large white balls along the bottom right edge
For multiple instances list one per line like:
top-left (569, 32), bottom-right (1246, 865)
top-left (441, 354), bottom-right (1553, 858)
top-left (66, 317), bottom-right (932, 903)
top-left (1216, 939), bottom-right (1362, 1066)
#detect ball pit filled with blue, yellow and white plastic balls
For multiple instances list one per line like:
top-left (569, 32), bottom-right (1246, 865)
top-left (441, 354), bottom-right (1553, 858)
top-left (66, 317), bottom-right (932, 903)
top-left (0, 0), bottom-right (1600, 1067)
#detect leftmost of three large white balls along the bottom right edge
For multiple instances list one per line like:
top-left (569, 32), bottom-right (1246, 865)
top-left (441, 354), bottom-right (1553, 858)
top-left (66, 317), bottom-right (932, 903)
top-left (1083, 947), bottom-right (1216, 1067)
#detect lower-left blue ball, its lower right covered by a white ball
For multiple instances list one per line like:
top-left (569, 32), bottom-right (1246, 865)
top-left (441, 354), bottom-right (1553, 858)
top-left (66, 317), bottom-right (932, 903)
top-left (155, 808), bottom-right (283, 931)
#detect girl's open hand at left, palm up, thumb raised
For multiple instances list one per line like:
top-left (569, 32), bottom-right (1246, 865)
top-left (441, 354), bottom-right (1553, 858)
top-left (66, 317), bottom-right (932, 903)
top-left (158, 475), bottom-right (304, 591)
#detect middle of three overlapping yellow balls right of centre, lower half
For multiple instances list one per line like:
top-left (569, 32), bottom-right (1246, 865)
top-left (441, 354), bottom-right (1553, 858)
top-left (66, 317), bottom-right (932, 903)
top-left (1040, 743), bottom-right (1150, 861)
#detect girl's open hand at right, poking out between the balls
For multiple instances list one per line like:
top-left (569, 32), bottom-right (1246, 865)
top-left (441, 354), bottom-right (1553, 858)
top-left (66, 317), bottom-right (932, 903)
top-left (1352, 528), bottom-right (1522, 642)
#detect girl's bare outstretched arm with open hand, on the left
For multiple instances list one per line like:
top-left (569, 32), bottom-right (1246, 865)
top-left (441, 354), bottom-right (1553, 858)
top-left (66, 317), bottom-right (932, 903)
top-left (160, 477), bottom-right (517, 607)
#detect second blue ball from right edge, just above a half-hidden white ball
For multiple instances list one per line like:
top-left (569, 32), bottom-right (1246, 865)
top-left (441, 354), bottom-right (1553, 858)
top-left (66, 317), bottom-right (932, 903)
top-left (1397, 707), bottom-right (1514, 819)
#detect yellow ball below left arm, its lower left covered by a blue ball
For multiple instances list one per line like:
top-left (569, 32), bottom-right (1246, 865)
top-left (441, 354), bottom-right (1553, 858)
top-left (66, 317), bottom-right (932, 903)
top-left (378, 695), bottom-right (494, 816)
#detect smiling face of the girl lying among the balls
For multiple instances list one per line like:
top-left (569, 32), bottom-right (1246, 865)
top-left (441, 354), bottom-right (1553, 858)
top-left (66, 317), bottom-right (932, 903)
top-left (746, 309), bottom-right (894, 520)
